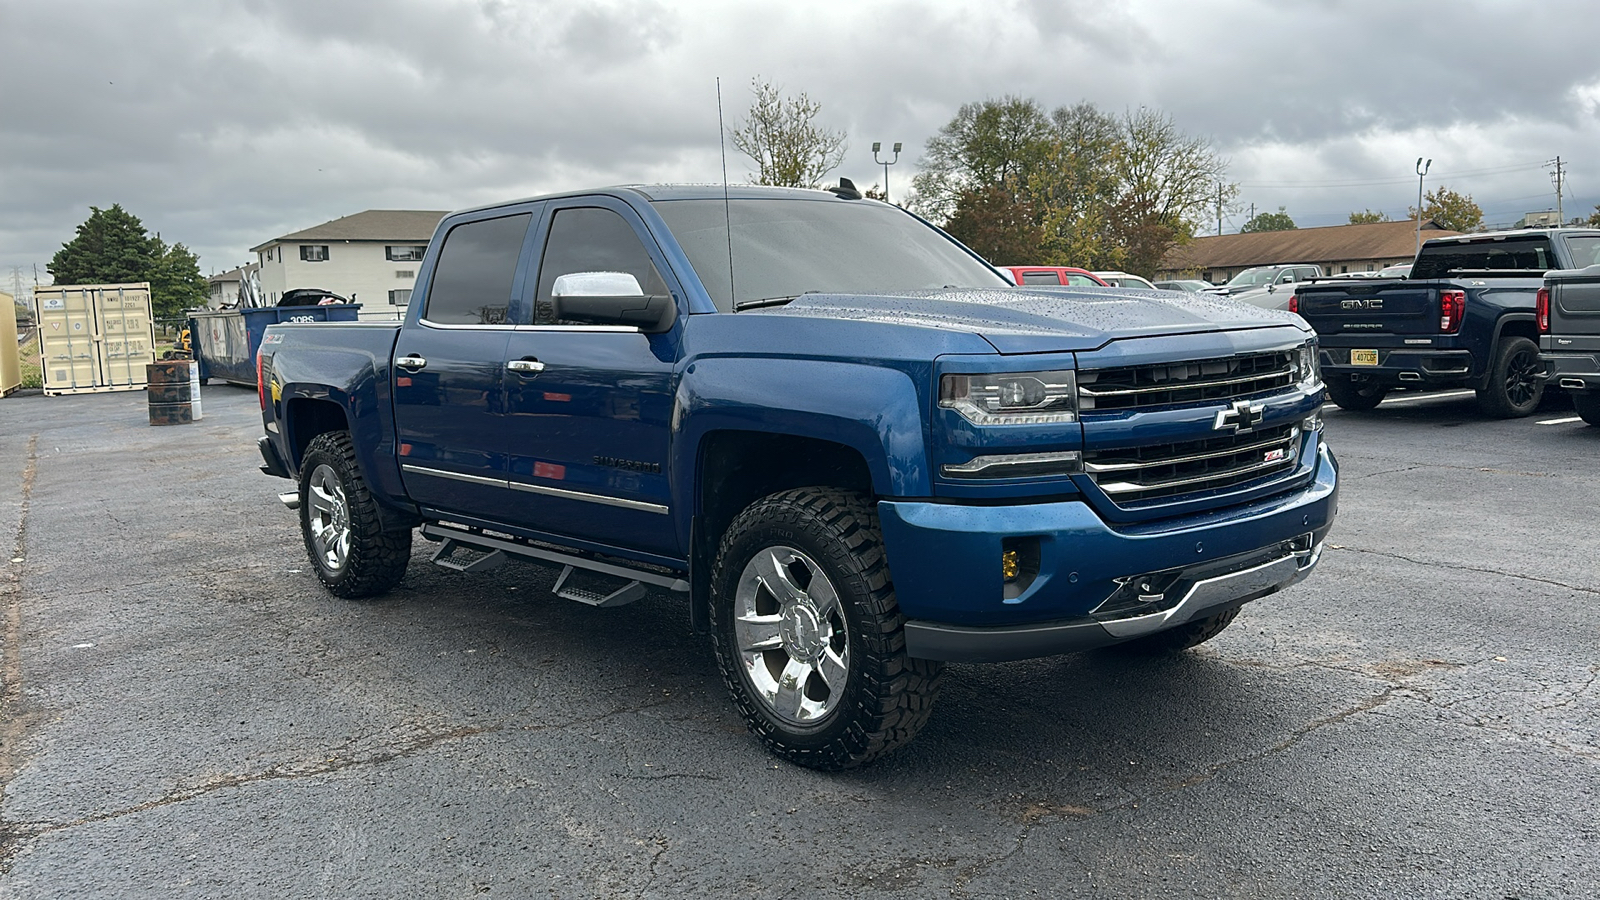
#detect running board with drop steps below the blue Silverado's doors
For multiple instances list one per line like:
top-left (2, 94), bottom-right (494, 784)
top-left (422, 522), bottom-right (690, 607)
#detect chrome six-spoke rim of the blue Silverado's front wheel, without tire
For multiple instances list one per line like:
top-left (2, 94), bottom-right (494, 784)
top-left (733, 546), bottom-right (850, 725)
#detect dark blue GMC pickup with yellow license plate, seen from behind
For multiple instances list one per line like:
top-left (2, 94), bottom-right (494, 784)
top-left (1291, 229), bottom-right (1600, 418)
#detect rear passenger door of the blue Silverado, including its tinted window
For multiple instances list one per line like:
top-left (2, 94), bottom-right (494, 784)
top-left (390, 208), bottom-right (536, 517)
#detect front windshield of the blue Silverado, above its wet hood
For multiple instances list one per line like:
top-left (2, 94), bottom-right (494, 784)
top-left (654, 197), bottom-right (1014, 312)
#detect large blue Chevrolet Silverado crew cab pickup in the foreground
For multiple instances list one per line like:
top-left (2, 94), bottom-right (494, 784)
top-left (258, 183), bottom-right (1338, 769)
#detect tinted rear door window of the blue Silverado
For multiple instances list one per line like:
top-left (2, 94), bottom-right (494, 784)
top-left (422, 213), bottom-right (531, 325)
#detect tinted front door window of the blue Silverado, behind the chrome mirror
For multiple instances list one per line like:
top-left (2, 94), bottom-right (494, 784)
top-left (534, 207), bottom-right (667, 325)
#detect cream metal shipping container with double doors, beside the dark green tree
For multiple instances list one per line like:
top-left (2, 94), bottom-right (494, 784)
top-left (34, 282), bottom-right (155, 396)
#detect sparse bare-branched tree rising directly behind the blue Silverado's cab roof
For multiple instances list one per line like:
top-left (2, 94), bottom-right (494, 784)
top-left (733, 78), bottom-right (846, 187)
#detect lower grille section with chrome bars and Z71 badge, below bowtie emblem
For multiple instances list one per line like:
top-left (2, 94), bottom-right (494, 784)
top-left (1083, 423), bottom-right (1301, 506)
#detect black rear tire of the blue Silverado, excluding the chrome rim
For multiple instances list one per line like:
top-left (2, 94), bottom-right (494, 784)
top-left (299, 431), bottom-right (411, 599)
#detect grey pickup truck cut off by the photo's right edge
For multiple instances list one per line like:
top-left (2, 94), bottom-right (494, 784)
top-left (1538, 256), bottom-right (1600, 426)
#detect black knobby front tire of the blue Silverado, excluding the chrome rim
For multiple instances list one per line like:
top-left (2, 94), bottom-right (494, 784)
top-left (710, 487), bottom-right (944, 770)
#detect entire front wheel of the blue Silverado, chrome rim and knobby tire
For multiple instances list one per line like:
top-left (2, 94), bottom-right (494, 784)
top-left (712, 487), bottom-right (942, 770)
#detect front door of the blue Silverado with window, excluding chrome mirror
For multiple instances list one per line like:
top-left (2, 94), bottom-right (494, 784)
top-left (499, 197), bottom-right (685, 556)
